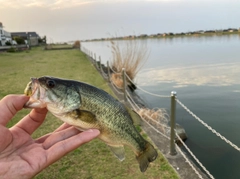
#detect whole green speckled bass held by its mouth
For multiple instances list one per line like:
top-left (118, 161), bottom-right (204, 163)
top-left (24, 76), bottom-right (158, 172)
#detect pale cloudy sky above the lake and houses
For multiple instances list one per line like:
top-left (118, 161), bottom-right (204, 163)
top-left (0, 0), bottom-right (240, 43)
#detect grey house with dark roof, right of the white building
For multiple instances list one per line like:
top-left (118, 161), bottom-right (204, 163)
top-left (11, 32), bottom-right (40, 46)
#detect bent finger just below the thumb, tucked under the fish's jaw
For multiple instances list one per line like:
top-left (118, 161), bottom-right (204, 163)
top-left (13, 108), bottom-right (47, 135)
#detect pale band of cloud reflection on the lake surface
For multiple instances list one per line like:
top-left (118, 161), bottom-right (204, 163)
top-left (138, 62), bottom-right (240, 87)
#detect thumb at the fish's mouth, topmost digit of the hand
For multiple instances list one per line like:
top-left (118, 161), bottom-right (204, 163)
top-left (0, 95), bottom-right (29, 126)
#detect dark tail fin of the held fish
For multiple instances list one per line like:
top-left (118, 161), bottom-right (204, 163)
top-left (136, 142), bottom-right (158, 172)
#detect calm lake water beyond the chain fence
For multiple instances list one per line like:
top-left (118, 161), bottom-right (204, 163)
top-left (82, 35), bottom-right (240, 179)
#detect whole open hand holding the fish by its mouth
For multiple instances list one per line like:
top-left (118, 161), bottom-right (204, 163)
top-left (0, 95), bottom-right (99, 179)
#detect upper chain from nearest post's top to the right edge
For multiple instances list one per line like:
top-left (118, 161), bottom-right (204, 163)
top-left (176, 99), bottom-right (240, 151)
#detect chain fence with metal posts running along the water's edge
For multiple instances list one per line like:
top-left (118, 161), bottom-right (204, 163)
top-left (82, 47), bottom-right (240, 179)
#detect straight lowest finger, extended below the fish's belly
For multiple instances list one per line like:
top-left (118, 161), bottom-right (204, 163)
top-left (47, 129), bottom-right (100, 165)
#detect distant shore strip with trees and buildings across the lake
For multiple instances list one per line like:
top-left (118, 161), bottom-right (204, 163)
top-left (82, 28), bottom-right (240, 42)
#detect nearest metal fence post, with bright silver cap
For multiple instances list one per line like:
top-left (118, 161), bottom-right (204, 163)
top-left (170, 91), bottom-right (177, 155)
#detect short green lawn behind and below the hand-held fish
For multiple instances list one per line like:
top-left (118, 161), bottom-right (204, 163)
top-left (0, 48), bottom-right (178, 179)
